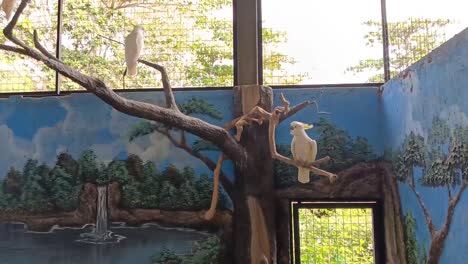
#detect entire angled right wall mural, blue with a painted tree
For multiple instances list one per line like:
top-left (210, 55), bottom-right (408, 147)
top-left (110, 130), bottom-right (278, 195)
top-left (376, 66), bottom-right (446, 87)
top-left (383, 27), bottom-right (468, 264)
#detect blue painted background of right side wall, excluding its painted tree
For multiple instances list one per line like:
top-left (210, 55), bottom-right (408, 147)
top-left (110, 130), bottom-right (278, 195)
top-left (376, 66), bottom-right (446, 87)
top-left (382, 27), bottom-right (468, 264)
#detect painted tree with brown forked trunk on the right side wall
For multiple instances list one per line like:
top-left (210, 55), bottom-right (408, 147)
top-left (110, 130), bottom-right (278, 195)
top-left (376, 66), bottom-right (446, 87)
top-left (394, 118), bottom-right (468, 264)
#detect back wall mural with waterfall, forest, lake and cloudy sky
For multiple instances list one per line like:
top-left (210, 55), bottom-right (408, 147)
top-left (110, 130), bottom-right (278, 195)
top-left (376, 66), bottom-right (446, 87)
top-left (0, 88), bottom-right (383, 263)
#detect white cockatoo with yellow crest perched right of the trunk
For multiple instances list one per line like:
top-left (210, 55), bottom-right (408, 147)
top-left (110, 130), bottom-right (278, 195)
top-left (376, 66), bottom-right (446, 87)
top-left (290, 121), bottom-right (317, 183)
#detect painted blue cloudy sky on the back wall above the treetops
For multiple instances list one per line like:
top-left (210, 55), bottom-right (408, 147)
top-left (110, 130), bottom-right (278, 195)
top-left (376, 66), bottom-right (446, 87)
top-left (0, 88), bottom-right (382, 182)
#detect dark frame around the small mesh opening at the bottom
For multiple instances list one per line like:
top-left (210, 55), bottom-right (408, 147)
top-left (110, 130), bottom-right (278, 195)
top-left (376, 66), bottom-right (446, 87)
top-left (289, 199), bottom-right (385, 264)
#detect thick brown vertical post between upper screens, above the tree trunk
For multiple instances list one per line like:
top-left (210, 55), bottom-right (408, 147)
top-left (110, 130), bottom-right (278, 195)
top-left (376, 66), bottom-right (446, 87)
top-left (234, 0), bottom-right (259, 86)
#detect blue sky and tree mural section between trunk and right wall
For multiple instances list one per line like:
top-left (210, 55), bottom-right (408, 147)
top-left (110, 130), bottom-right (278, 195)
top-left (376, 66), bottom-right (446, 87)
top-left (274, 88), bottom-right (383, 188)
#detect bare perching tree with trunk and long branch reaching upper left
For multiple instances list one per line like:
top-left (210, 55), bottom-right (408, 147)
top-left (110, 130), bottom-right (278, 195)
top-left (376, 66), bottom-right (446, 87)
top-left (0, 0), bottom-right (336, 263)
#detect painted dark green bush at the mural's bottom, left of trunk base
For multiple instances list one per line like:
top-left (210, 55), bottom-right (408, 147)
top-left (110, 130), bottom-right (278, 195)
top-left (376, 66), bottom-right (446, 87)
top-left (152, 236), bottom-right (222, 264)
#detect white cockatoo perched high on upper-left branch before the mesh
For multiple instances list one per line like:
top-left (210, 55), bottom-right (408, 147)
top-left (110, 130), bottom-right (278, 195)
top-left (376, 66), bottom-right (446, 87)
top-left (124, 26), bottom-right (144, 76)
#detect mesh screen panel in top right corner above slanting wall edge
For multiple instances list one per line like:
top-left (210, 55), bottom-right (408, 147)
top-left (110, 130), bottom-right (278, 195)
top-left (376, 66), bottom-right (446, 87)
top-left (387, 0), bottom-right (468, 80)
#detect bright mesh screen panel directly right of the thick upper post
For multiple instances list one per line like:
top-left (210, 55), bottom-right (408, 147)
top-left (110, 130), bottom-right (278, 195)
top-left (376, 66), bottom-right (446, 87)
top-left (262, 0), bottom-right (384, 85)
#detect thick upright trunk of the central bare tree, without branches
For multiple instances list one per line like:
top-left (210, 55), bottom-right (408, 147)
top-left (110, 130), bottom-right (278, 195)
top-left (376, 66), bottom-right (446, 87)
top-left (233, 87), bottom-right (276, 264)
